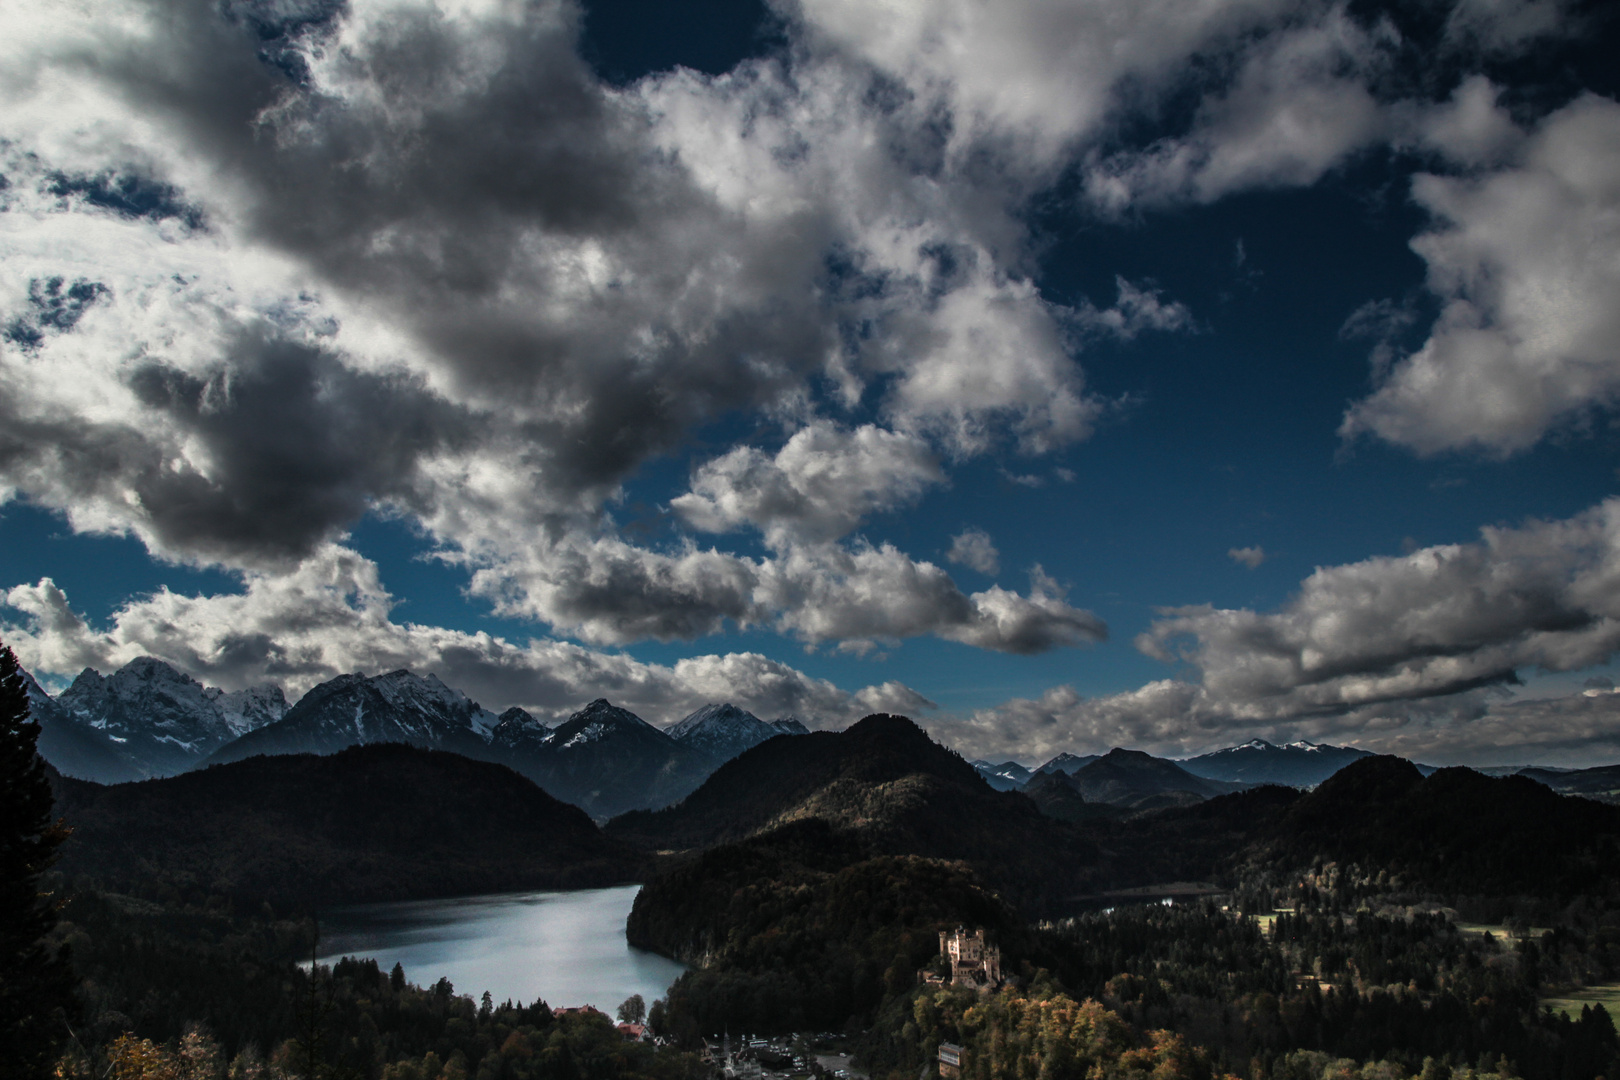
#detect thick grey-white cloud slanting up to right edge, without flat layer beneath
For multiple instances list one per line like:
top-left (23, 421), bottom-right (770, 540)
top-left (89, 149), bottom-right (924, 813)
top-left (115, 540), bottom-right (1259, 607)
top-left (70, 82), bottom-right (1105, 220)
top-left (1137, 499), bottom-right (1620, 719)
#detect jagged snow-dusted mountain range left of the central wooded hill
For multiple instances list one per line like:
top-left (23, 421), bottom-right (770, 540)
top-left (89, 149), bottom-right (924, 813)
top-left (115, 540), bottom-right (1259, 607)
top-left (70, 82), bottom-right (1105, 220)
top-left (29, 657), bottom-right (807, 819)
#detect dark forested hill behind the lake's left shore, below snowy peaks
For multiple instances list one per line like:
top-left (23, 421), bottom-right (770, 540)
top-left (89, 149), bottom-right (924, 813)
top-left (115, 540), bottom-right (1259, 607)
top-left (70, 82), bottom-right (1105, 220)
top-left (55, 745), bottom-right (646, 910)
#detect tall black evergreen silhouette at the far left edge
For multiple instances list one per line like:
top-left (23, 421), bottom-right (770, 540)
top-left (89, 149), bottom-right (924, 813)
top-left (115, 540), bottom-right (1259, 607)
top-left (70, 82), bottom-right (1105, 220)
top-left (0, 644), bottom-right (73, 1077)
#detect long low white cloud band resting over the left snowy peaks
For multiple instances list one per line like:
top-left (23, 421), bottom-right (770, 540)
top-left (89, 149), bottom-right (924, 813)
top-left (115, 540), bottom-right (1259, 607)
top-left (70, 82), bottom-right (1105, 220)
top-left (0, 546), bottom-right (932, 724)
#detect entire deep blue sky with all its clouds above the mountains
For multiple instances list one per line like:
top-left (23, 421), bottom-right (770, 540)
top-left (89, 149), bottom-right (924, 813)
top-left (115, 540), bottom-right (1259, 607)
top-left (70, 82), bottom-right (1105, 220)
top-left (0, 0), bottom-right (1620, 766)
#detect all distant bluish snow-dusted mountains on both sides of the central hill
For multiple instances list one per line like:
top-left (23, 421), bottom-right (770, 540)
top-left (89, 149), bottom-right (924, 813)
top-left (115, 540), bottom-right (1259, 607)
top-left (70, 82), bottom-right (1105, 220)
top-left (28, 657), bottom-right (1620, 821)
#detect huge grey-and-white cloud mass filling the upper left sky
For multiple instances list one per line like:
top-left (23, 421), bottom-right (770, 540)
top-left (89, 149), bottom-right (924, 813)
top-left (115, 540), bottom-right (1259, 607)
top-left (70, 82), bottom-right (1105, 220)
top-left (0, 0), bottom-right (1189, 649)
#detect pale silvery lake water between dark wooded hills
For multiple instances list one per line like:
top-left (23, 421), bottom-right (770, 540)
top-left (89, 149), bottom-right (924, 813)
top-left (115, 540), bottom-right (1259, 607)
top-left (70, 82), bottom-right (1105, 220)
top-left (321, 886), bottom-right (687, 1015)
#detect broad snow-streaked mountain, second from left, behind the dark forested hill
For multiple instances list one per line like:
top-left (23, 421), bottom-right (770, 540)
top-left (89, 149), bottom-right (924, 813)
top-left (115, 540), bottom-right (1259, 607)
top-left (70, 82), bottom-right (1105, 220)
top-left (207, 670), bottom-right (498, 764)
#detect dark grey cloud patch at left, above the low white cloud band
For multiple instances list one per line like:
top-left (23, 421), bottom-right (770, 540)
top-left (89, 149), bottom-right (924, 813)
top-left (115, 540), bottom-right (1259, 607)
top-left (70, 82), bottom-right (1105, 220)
top-left (0, 330), bottom-right (473, 562)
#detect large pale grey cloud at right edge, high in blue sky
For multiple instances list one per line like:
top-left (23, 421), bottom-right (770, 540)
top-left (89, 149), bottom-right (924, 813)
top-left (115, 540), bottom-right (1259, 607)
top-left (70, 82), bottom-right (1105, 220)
top-left (1340, 96), bottom-right (1620, 455)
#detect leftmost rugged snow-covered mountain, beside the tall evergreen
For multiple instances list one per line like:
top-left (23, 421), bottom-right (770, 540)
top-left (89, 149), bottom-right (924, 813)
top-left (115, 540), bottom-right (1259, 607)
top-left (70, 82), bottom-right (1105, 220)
top-left (47, 656), bottom-right (287, 776)
